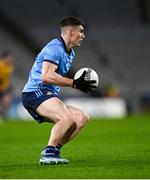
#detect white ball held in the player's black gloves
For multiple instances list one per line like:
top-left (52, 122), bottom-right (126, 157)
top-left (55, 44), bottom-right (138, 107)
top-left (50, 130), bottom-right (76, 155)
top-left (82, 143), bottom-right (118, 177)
top-left (74, 68), bottom-right (99, 91)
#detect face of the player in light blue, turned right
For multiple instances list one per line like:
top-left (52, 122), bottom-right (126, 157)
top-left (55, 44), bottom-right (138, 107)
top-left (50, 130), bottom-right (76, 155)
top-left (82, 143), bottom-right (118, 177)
top-left (71, 25), bottom-right (85, 46)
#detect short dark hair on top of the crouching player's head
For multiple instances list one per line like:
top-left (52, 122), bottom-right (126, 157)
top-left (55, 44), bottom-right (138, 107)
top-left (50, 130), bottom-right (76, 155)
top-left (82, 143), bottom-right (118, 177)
top-left (60, 16), bottom-right (84, 28)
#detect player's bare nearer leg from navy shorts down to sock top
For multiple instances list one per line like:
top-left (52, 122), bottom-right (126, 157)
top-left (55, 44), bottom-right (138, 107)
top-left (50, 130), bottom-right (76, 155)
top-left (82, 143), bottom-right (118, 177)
top-left (36, 97), bottom-right (75, 146)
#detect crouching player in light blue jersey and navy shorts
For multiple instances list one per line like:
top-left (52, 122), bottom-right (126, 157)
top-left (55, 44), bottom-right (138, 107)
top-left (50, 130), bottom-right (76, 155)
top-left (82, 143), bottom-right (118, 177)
top-left (22, 17), bottom-right (95, 164)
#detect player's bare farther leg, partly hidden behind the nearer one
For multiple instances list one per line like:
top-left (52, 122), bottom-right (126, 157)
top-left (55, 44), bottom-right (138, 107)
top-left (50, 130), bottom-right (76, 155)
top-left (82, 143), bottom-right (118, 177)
top-left (60, 106), bottom-right (89, 146)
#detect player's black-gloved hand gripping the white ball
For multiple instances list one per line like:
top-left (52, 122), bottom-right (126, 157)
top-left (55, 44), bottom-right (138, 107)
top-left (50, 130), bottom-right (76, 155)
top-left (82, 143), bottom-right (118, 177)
top-left (73, 71), bottom-right (96, 93)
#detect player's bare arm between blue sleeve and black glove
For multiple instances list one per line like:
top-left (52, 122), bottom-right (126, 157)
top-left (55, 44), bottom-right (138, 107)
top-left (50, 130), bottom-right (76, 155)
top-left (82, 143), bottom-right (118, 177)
top-left (42, 61), bottom-right (73, 87)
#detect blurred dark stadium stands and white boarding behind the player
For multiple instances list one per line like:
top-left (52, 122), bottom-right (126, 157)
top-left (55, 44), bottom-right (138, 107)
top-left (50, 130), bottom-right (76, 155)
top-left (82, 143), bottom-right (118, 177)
top-left (0, 0), bottom-right (150, 119)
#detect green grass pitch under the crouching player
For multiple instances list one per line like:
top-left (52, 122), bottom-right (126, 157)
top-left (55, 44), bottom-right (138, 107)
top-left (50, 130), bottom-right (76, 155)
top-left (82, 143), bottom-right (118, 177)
top-left (0, 115), bottom-right (150, 179)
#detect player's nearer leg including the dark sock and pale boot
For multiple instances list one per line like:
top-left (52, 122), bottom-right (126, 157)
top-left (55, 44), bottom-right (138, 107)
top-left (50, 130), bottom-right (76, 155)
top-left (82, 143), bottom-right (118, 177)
top-left (36, 97), bottom-right (75, 164)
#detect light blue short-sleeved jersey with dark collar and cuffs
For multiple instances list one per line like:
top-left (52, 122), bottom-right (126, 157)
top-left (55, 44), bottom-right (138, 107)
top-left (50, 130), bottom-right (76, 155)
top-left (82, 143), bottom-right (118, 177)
top-left (23, 37), bottom-right (75, 94)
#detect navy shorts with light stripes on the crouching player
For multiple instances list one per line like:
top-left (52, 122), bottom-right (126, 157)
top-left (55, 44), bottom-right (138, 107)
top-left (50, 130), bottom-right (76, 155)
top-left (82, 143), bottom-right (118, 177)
top-left (22, 89), bottom-right (59, 123)
